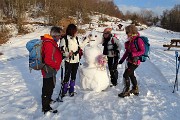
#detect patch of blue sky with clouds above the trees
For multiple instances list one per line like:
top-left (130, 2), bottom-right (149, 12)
top-left (114, 0), bottom-right (180, 15)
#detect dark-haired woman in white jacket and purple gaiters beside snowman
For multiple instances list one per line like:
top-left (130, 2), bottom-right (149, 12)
top-left (60, 24), bottom-right (88, 97)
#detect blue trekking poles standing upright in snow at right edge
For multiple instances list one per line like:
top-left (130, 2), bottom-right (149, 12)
top-left (172, 51), bottom-right (180, 93)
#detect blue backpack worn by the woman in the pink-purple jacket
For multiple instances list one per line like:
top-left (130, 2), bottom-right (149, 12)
top-left (134, 36), bottom-right (150, 62)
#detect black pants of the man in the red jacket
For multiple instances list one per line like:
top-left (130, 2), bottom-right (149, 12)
top-left (41, 77), bottom-right (55, 110)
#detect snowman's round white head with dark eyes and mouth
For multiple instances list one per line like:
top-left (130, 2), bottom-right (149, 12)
top-left (89, 31), bottom-right (102, 47)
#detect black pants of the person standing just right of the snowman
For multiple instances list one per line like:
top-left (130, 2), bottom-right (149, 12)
top-left (107, 56), bottom-right (118, 85)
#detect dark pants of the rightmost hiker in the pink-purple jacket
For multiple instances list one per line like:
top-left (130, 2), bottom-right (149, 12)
top-left (123, 62), bottom-right (138, 87)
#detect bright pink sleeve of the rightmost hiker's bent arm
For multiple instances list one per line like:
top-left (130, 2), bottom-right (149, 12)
top-left (132, 38), bottom-right (145, 57)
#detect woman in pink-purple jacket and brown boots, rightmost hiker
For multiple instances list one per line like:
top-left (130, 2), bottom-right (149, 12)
top-left (118, 24), bottom-right (145, 98)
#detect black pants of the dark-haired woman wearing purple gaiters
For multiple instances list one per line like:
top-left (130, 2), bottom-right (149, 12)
top-left (63, 61), bottom-right (79, 83)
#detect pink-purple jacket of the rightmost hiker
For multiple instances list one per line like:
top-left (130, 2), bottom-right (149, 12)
top-left (121, 34), bottom-right (145, 65)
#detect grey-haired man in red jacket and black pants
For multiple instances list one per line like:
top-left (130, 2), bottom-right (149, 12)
top-left (41, 27), bottom-right (62, 113)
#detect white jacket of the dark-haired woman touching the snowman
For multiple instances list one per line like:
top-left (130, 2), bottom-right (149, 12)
top-left (60, 35), bottom-right (89, 63)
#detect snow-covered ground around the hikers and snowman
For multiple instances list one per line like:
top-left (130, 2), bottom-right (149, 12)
top-left (0, 22), bottom-right (180, 120)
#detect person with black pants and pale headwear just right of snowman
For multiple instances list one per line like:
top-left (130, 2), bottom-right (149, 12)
top-left (102, 28), bottom-right (121, 87)
